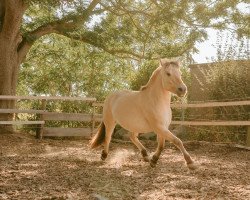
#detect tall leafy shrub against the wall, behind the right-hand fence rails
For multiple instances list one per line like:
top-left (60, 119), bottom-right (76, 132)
top-left (183, 31), bottom-right (250, 144)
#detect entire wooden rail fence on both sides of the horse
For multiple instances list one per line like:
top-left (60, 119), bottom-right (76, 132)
top-left (0, 96), bottom-right (250, 146)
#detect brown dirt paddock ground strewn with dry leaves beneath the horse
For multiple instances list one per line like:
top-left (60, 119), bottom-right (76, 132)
top-left (0, 134), bottom-right (250, 200)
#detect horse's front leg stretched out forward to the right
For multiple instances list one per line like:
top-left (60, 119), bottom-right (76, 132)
top-left (155, 126), bottom-right (197, 169)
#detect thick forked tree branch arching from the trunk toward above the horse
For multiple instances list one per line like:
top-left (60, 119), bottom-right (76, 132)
top-left (18, 0), bottom-right (195, 62)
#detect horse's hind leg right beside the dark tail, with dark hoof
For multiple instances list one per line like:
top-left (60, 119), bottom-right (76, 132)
top-left (101, 121), bottom-right (115, 160)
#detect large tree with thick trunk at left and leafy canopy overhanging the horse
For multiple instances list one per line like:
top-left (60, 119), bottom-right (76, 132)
top-left (0, 0), bottom-right (249, 122)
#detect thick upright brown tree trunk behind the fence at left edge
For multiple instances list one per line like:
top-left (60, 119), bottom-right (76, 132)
top-left (0, 0), bottom-right (25, 133)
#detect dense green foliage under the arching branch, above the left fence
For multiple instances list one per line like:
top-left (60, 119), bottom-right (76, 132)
top-left (18, 35), bottom-right (135, 101)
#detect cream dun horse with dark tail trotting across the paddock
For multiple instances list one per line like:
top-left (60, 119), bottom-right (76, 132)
top-left (90, 58), bottom-right (196, 170)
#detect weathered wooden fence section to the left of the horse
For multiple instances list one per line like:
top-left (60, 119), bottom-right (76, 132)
top-left (0, 96), bottom-right (101, 138)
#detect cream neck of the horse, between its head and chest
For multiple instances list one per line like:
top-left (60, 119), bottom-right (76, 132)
top-left (145, 72), bottom-right (171, 106)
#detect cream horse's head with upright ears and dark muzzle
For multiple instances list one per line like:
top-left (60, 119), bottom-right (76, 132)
top-left (160, 59), bottom-right (187, 97)
